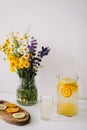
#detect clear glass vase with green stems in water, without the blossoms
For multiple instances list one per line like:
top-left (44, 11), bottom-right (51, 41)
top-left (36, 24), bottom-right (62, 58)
top-left (17, 78), bottom-right (38, 106)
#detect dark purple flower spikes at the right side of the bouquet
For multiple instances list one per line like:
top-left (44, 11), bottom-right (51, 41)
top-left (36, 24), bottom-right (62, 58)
top-left (27, 37), bottom-right (50, 77)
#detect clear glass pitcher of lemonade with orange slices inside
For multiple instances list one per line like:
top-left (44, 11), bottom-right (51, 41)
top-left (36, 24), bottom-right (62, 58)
top-left (57, 75), bottom-right (78, 116)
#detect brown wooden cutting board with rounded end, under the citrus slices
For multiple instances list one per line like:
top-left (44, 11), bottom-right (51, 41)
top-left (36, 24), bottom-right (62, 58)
top-left (0, 100), bottom-right (30, 125)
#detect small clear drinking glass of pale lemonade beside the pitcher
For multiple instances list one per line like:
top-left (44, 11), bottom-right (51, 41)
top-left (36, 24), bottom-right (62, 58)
top-left (40, 95), bottom-right (53, 120)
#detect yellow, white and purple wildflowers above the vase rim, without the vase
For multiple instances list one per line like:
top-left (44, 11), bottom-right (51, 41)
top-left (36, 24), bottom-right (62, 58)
top-left (0, 32), bottom-right (50, 79)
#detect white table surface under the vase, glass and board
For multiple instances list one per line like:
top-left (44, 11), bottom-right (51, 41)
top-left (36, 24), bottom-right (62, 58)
top-left (0, 93), bottom-right (87, 130)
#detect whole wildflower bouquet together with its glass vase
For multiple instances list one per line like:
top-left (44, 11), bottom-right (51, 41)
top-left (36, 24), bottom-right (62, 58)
top-left (0, 32), bottom-right (50, 105)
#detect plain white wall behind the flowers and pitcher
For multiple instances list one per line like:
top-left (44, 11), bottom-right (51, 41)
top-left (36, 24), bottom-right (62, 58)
top-left (0, 0), bottom-right (87, 96)
